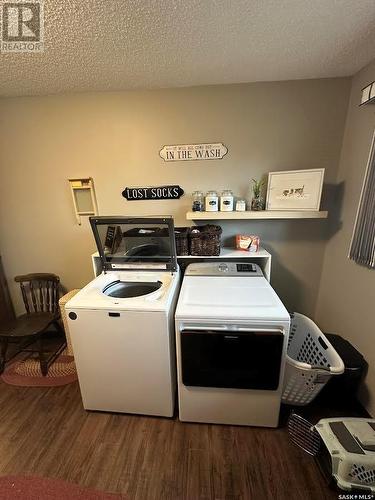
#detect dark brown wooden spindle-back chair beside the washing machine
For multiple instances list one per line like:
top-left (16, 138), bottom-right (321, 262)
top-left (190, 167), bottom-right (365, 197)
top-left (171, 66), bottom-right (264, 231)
top-left (0, 273), bottom-right (66, 376)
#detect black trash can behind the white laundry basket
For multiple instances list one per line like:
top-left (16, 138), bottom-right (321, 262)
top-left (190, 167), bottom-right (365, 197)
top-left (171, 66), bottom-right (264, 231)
top-left (321, 333), bottom-right (367, 404)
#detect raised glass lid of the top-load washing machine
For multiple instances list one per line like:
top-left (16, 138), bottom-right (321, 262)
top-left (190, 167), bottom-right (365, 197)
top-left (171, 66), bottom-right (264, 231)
top-left (90, 216), bottom-right (177, 272)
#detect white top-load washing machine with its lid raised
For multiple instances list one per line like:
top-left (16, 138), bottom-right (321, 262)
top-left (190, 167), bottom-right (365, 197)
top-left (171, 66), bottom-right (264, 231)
top-left (65, 217), bottom-right (179, 417)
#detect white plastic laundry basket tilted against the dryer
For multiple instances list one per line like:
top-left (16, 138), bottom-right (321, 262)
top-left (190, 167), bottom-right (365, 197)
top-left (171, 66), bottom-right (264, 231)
top-left (282, 313), bottom-right (345, 406)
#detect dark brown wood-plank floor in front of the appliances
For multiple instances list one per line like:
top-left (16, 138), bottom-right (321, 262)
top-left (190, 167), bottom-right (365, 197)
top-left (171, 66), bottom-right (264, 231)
top-left (0, 382), bottom-right (360, 500)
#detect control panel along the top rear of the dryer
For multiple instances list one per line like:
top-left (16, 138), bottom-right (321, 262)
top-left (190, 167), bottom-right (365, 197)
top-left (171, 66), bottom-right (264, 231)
top-left (185, 262), bottom-right (263, 278)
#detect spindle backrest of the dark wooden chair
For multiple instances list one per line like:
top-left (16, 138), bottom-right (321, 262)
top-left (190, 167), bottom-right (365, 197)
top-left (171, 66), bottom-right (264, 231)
top-left (14, 273), bottom-right (60, 314)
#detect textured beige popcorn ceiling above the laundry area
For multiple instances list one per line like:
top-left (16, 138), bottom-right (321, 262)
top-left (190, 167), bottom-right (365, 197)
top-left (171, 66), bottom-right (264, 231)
top-left (0, 0), bottom-right (375, 96)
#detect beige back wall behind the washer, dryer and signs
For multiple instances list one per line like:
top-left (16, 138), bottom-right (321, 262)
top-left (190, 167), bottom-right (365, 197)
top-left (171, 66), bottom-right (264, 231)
top-left (0, 79), bottom-right (350, 314)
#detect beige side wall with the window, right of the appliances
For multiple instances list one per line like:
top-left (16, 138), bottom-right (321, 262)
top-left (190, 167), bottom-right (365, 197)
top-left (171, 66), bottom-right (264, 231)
top-left (317, 61), bottom-right (375, 416)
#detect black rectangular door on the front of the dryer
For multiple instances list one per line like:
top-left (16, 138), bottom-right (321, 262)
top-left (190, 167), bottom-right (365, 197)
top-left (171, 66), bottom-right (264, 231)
top-left (181, 329), bottom-right (284, 391)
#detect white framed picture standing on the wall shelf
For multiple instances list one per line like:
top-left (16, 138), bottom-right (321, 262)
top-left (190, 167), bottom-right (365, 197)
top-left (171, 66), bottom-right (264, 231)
top-left (266, 168), bottom-right (324, 211)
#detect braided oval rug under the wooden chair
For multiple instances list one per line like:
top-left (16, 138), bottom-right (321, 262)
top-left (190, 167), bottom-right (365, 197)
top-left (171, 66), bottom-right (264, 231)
top-left (1, 354), bottom-right (77, 387)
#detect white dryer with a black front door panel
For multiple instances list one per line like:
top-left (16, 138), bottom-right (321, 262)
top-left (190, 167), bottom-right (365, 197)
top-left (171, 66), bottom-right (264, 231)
top-left (176, 262), bottom-right (290, 427)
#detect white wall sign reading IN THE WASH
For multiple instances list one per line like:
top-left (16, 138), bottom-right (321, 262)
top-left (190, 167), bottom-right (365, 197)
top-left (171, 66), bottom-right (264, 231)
top-left (159, 142), bottom-right (228, 161)
